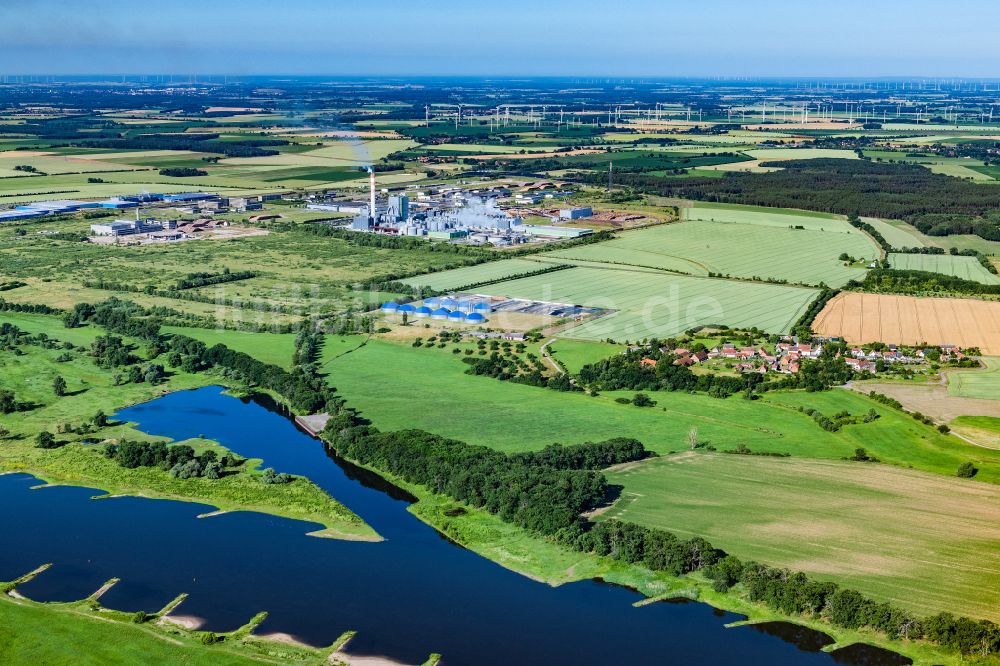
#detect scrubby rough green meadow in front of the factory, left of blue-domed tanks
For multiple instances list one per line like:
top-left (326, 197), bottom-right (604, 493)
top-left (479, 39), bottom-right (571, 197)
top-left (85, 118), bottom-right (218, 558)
top-left (0, 213), bottom-right (476, 324)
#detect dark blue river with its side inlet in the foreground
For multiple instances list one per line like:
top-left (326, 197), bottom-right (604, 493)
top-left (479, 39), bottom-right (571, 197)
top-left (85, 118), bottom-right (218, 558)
top-left (0, 387), bottom-right (908, 666)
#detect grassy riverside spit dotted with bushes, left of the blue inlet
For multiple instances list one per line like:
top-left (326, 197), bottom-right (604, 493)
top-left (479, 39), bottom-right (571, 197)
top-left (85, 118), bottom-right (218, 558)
top-left (0, 313), bottom-right (377, 539)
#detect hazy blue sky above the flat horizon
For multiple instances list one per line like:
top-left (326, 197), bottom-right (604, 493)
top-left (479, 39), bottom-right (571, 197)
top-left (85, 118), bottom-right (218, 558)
top-left (0, 0), bottom-right (1000, 77)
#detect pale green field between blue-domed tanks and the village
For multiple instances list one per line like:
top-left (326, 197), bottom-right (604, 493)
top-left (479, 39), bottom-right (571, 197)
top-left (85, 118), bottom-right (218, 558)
top-left (478, 265), bottom-right (816, 342)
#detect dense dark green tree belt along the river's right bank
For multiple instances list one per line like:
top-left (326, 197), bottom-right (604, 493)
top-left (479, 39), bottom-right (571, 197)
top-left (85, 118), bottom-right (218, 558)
top-left (323, 418), bottom-right (1000, 655)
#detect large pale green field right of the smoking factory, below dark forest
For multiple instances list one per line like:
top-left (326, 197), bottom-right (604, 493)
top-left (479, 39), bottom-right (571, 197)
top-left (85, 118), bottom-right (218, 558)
top-left (544, 215), bottom-right (878, 286)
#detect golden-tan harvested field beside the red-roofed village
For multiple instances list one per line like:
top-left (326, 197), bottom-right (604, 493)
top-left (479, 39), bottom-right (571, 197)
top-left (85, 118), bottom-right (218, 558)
top-left (813, 293), bottom-right (1000, 355)
